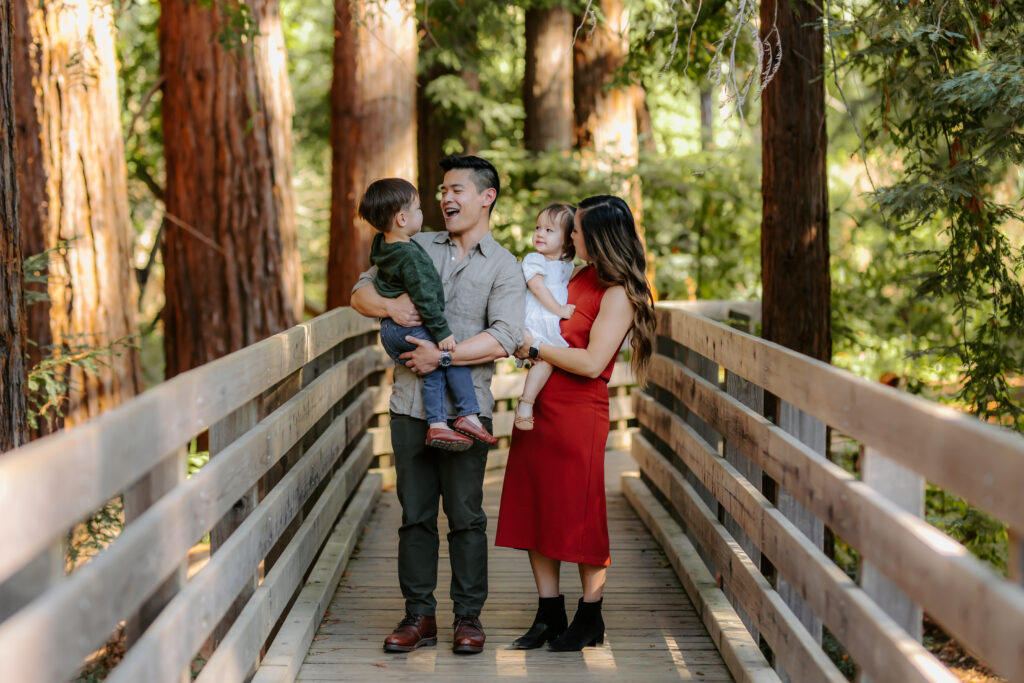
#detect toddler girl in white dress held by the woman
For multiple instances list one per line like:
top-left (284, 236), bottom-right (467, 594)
top-left (515, 204), bottom-right (575, 430)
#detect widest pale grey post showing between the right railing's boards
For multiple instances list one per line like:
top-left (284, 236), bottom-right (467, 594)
top-left (858, 447), bottom-right (925, 683)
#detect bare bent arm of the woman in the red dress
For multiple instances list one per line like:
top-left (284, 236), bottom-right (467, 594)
top-left (524, 287), bottom-right (633, 377)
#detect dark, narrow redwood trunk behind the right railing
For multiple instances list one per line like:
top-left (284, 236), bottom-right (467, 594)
top-left (761, 0), bottom-right (831, 362)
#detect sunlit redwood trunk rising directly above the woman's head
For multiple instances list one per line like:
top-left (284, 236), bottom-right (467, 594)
top-left (572, 0), bottom-right (654, 288)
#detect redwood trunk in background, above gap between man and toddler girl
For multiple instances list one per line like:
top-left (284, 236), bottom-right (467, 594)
top-left (522, 7), bottom-right (573, 152)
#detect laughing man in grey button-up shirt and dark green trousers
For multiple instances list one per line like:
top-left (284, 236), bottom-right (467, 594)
top-left (351, 152), bottom-right (526, 654)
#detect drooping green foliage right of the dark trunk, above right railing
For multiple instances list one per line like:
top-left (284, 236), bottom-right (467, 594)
top-left (834, 1), bottom-right (1024, 430)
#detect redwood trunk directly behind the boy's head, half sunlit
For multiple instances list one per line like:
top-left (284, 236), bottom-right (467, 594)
top-left (327, 0), bottom-right (419, 308)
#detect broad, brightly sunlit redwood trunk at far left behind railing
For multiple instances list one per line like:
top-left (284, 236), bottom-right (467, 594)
top-left (15, 0), bottom-right (140, 425)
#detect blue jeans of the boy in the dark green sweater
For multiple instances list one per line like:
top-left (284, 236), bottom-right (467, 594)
top-left (381, 317), bottom-right (480, 424)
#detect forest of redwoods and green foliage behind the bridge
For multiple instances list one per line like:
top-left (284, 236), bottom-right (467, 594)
top-left (0, 0), bottom-right (1024, 675)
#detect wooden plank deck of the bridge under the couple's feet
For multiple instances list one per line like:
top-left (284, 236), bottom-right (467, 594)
top-left (299, 453), bottom-right (732, 682)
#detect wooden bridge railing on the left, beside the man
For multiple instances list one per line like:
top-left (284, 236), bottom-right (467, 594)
top-left (0, 309), bottom-right (390, 683)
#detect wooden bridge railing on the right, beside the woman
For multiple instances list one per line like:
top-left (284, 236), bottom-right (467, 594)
top-left (624, 305), bottom-right (1024, 682)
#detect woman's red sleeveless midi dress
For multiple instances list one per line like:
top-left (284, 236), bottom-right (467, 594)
top-left (496, 266), bottom-right (615, 566)
